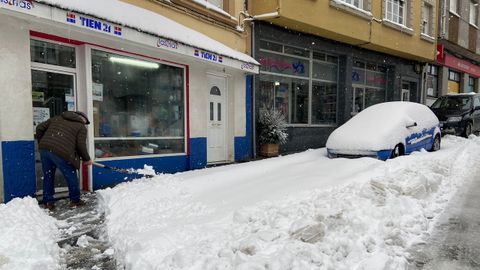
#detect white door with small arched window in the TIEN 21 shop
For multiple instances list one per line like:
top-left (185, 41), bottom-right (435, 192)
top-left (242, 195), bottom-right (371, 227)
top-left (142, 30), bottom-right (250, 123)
top-left (207, 75), bottom-right (227, 163)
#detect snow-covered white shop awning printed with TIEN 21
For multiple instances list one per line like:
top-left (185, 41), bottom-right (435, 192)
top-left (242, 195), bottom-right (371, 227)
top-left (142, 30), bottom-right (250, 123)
top-left (0, 0), bottom-right (259, 73)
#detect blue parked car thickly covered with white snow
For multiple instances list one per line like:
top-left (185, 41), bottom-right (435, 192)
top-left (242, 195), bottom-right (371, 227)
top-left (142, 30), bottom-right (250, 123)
top-left (327, 101), bottom-right (441, 160)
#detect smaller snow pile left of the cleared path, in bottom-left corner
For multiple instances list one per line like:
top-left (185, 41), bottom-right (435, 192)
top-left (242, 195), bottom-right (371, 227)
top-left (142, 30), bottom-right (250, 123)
top-left (0, 198), bottom-right (60, 270)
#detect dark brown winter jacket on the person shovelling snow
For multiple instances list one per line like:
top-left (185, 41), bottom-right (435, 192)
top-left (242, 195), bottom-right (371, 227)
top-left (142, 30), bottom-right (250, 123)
top-left (35, 111), bottom-right (90, 169)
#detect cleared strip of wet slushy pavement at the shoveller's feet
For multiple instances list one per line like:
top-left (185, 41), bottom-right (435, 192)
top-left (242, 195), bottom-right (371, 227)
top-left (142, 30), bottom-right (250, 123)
top-left (49, 193), bottom-right (117, 270)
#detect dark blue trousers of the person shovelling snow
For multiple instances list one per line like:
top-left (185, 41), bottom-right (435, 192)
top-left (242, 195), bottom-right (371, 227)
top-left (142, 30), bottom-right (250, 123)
top-left (40, 150), bottom-right (80, 203)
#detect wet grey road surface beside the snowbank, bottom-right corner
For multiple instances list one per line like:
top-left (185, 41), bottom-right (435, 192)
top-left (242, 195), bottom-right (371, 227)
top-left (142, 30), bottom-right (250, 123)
top-left (409, 177), bottom-right (480, 270)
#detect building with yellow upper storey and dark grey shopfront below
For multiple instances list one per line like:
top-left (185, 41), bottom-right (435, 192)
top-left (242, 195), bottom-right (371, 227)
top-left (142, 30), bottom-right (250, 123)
top-left (248, 0), bottom-right (437, 153)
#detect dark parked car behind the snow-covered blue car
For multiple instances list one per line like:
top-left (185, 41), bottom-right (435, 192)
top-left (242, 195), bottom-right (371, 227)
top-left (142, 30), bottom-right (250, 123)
top-left (430, 93), bottom-right (480, 137)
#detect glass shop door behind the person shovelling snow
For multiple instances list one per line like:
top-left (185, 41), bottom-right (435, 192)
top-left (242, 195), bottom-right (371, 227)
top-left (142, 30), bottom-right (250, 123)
top-left (32, 69), bottom-right (76, 197)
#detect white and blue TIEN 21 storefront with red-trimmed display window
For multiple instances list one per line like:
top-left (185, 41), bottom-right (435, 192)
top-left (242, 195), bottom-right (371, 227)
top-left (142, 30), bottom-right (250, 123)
top-left (0, 1), bottom-right (258, 201)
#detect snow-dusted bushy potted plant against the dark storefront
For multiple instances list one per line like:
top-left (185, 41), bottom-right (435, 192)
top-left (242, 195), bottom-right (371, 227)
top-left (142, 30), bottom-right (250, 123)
top-left (257, 109), bottom-right (288, 157)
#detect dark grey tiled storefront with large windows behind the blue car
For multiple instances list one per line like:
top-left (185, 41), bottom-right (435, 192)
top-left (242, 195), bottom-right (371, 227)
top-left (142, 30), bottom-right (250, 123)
top-left (254, 23), bottom-right (422, 153)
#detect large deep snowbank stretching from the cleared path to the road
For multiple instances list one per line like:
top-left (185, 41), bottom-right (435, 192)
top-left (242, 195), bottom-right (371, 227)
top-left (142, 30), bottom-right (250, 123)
top-left (98, 137), bottom-right (480, 270)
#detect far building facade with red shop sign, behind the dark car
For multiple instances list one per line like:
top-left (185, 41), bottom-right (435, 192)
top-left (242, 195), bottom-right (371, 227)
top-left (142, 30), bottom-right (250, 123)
top-left (427, 0), bottom-right (480, 104)
